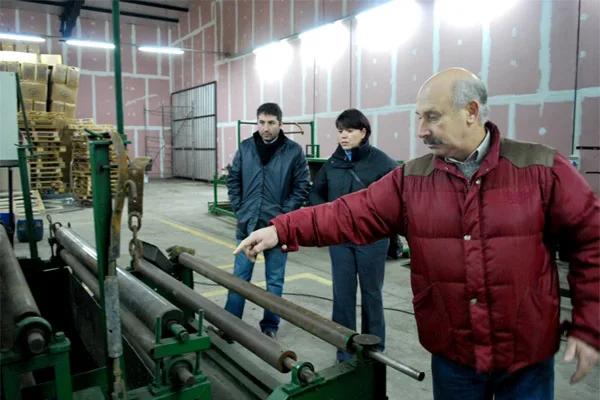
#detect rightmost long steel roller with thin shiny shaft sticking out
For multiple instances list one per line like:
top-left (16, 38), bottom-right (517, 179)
top-left (179, 253), bottom-right (425, 381)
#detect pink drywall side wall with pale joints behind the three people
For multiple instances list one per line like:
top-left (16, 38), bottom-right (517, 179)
top-left (171, 0), bottom-right (600, 192)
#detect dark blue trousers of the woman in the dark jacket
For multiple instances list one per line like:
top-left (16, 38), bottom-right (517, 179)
top-left (329, 239), bottom-right (390, 361)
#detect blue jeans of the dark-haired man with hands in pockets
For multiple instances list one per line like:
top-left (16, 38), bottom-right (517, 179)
top-left (225, 240), bottom-right (287, 332)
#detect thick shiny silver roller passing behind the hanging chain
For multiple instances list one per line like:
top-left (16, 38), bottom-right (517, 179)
top-left (55, 227), bottom-right (183, 332)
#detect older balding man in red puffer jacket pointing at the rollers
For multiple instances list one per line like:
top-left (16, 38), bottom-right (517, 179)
top-left (236, 69), bottom-right (600, 400)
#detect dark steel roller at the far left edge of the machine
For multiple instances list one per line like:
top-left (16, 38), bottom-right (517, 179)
top-left (0, 225), bottom-right (50, 354)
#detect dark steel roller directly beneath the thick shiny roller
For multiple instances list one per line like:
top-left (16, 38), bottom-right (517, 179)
top-left (60, 250), bottom-right (196, 388)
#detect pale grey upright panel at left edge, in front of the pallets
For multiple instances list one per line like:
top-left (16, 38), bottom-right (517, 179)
top-left (0, 72), bottom-right (19, 166)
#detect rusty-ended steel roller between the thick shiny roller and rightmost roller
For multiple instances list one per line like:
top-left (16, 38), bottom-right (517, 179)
top-left (139, 260), bottom-right (296, 372)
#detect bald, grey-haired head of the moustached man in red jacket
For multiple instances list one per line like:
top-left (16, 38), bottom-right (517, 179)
top-left (417, 68), bottom-right (488, 159)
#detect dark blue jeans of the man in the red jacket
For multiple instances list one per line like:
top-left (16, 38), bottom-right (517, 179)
top-left (431, 355), bottom-right (554, 400)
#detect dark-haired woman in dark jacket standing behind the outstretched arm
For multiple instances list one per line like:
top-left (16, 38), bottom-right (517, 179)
top-left (308, 109), bottom-right (397, 362)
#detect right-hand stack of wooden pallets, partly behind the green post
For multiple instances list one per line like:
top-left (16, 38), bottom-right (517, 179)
top-left (66, 119), bottom-right (118, 200)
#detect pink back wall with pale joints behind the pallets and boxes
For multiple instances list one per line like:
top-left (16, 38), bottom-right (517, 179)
top-left (0, 8), bottom-right (171, 177)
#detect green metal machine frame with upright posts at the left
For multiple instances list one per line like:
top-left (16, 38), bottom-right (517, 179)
top-left (0, 0), bottom-right (211, 400)
